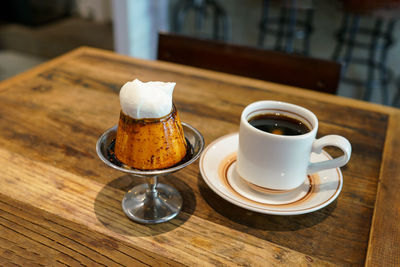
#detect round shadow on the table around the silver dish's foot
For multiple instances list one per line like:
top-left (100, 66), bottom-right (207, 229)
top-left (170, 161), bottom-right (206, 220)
top-left (94, 174), bottom-right (196, 236)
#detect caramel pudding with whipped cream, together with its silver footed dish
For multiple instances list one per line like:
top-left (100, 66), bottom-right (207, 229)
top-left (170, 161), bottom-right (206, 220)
top-left (96, 80), bottom-right (204, 223)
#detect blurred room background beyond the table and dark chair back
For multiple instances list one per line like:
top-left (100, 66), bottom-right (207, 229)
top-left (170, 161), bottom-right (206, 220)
top-left (0, 0), bottom-right (400, 107)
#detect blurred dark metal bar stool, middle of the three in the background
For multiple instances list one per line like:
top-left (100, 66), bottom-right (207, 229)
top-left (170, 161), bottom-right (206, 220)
top-left (258, 0), bottom-right (314, 55)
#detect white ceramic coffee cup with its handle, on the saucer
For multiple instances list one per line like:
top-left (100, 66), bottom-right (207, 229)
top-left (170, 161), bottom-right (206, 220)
top-left (237, 101), bottom-right (351, 190)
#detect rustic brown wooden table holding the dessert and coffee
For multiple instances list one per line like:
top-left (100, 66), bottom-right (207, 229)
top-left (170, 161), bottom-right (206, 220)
top-left (0, 48), bottom-right (400, 266)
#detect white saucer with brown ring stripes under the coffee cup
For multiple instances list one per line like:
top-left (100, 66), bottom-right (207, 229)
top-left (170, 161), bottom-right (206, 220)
top-left (200, 133), bottom-right (343, 215)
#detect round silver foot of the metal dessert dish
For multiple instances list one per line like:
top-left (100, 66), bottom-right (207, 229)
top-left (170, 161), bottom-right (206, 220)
top-left (122, 184), bottom-right (182, 224)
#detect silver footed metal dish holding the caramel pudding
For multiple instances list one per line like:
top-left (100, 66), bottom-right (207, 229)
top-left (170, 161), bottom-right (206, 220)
top-left (96, 123), bottom-right (204, 224)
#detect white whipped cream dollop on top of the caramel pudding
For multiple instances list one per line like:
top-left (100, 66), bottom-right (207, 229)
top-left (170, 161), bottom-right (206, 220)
top-left (119, 79), bottom-right (175, 119)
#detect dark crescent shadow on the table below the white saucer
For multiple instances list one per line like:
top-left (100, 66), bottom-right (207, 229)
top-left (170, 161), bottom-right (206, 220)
top-left (198, 175), bottom-right (337, 231)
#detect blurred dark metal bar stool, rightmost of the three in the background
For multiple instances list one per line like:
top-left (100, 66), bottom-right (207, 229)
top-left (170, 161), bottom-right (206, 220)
top-left (332, 1), bottom-right (397, 105)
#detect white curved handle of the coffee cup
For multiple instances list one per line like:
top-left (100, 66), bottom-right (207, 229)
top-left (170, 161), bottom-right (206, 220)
top-left (307, 135), bottom-right (351, 174)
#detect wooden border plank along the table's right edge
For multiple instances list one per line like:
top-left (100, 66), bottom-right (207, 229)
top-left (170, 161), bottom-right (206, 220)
top-left (365, 112), bottom-right (400, 266)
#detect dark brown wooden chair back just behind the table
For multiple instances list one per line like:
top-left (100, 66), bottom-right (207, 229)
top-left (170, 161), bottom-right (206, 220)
top-left (158, 33), bottom-right (341, 94)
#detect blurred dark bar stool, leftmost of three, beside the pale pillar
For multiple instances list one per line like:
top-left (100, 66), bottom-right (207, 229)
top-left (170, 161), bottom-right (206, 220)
top-left (172, 0), bottom-right (230, 41)
